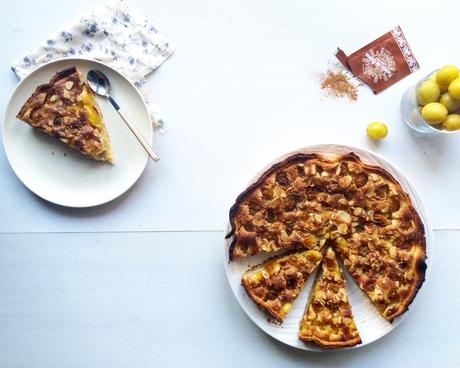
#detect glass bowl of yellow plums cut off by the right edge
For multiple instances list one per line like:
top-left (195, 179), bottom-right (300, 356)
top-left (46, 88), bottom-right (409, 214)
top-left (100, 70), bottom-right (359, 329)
top-left (401, 65), bottom-right (460, 134)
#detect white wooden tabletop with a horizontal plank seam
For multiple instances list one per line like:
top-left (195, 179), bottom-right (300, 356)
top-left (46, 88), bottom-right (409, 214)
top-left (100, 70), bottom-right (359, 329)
top-left (0, 0), bottom-right (460, 368)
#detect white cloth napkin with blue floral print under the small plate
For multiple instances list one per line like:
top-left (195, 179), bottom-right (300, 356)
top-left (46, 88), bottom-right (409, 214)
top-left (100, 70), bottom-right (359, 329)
top-left (11, 0), bottom-right (174, 127)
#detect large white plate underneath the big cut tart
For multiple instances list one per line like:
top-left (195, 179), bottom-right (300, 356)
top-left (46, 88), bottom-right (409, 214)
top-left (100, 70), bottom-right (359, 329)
top-left (224, 145), bottom-right (433, 351)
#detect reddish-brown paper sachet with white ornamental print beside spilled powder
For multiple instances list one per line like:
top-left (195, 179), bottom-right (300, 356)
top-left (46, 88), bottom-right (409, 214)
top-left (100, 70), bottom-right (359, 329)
top-left (336, 26), bottom-right (419, 94)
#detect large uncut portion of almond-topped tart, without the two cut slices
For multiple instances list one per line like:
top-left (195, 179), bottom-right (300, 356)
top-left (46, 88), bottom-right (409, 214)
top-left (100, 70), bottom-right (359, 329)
top-left (227, 153), bottom-right (426, 322)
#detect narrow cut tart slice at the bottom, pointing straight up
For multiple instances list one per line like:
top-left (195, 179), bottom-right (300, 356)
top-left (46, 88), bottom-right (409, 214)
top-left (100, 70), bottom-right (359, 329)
top-left (299, 248), bottom-right (361, 348)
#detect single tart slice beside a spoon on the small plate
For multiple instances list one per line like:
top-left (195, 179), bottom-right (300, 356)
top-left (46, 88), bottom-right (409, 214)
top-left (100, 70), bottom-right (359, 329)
top-left (17, 66), bottom-right (112, 162)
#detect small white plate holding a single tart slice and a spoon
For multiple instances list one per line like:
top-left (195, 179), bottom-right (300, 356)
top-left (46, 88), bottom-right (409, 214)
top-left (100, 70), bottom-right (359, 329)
top-left (3, 59), bottom-right (153, 207)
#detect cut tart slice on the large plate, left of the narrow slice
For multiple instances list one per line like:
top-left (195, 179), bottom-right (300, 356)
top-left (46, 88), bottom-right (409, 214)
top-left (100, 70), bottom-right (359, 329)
top-left (241, 250), bottom-right (322, 322)
